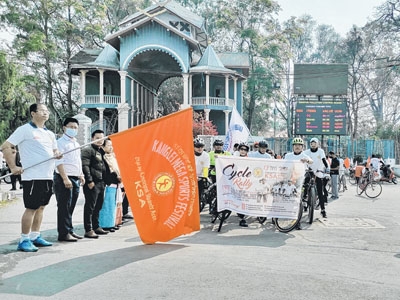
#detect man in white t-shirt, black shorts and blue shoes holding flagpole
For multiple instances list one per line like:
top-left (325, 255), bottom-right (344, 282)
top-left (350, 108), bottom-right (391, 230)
top-left (1, 103), bottom-right (62, 252)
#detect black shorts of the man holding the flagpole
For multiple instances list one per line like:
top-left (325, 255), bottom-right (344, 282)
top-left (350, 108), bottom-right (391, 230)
top-left (22, 180), bottom-right (53, 210)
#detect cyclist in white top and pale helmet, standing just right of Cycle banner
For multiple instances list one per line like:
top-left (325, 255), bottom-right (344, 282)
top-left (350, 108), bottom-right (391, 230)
top-left (304, 137), bottom-right (330, 218)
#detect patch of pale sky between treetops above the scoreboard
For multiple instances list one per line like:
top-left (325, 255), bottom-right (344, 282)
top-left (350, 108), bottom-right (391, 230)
top-left (275, 0), bottom-right (385, 37)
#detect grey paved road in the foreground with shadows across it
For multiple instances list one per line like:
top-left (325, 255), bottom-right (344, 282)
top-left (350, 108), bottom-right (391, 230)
top-left (0, 179), bottom-right (400, 300)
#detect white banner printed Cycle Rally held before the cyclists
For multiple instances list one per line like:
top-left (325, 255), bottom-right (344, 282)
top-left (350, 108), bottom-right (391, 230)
top-left (216, 156), bottom-right (305, 219)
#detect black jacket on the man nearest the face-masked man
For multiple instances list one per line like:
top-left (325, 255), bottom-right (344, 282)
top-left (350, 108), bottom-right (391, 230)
top-left (81, 144), bottom-right (106, 184)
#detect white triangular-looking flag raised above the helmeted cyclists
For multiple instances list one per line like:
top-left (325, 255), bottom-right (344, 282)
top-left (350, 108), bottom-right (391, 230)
top-left (224, 107), bottom-right (250, 151)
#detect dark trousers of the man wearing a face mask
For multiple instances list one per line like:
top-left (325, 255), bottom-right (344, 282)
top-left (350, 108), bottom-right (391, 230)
top-left (53, 174), bottom-right (80, 237)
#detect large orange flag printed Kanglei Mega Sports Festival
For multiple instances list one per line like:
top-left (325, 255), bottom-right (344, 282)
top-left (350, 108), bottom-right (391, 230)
top-left (110, 108), bottom-right (200, 244)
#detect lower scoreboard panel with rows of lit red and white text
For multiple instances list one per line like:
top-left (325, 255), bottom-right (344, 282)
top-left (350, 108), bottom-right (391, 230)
top-left (294, 100), bottom-right (347, 135)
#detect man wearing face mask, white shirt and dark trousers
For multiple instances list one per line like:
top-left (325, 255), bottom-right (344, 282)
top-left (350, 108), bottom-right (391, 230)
top-left (53, 118), bottom-right (85, 242)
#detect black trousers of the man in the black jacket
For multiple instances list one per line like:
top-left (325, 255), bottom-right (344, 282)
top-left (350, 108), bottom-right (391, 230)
top-left (83, 182), bottom-right (105, 232)
